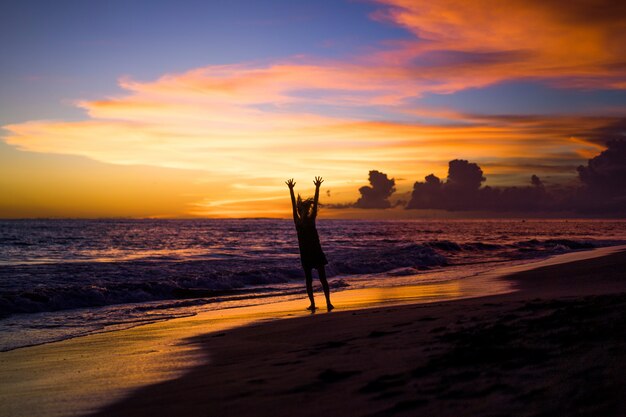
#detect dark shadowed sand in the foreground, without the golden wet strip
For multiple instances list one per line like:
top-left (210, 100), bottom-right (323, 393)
top-left (91, 252), bottom-right (626, 416)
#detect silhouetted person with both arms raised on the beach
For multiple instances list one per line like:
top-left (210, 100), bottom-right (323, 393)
top-left (285, 177), bottom-right (334, 313)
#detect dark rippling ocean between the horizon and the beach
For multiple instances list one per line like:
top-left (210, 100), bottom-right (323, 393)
top-left (0, 219), bottom-right (626, 351)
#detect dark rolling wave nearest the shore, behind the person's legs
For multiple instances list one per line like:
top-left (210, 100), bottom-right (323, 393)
top-left (0, 245), bottom-right (448, 316)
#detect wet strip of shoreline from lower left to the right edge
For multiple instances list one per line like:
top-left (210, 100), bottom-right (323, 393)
top-left (0, 246), bottom-right (624, 415)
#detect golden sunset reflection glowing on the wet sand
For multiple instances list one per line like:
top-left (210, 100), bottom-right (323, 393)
top-left (0, 275), bottom-right (511, 417)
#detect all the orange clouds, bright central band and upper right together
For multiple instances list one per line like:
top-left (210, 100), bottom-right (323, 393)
top-left (4, 0), bottom-right (626, 216)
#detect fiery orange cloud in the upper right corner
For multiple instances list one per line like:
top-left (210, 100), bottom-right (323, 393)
top-left (373, 0), bottom-right (626, 92)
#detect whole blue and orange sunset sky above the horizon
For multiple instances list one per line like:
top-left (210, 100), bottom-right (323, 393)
top-left (0, 0), bottom-right (626, 218)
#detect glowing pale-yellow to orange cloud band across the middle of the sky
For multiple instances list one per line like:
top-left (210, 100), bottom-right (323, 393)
top-left (5, 74), bottom-right (610, 187)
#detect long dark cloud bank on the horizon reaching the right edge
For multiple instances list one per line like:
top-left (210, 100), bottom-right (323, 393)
top-left (406, 135), bottom-right (626, 215)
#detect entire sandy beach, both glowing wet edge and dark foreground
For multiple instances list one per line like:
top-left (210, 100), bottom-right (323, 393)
top-left (0, 247), bottom-right (626, 416)
